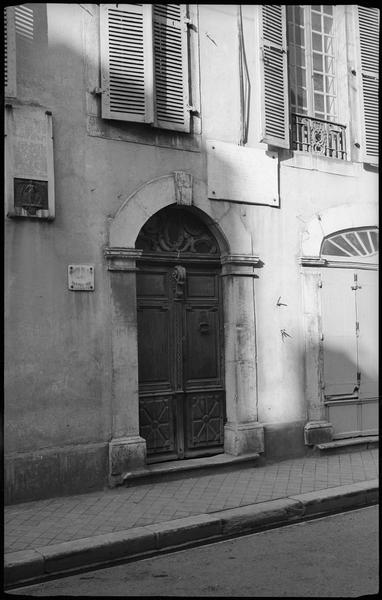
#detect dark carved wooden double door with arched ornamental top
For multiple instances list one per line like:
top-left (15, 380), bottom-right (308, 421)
top-left (135, 205), bottom-right (225, 462)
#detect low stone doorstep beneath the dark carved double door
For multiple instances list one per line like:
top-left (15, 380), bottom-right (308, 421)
top-left (121, 452), bottom-right (260, 484)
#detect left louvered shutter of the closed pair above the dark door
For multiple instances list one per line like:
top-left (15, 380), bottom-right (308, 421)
top-left (100, 4), bottom-right (153, 123)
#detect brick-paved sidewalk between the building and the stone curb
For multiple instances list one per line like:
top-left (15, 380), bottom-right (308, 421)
top-left (4, 449), bottom-right (378, 553)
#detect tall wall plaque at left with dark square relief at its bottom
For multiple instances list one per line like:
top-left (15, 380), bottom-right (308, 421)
top-left (5, 103), bottom-right (54, 219)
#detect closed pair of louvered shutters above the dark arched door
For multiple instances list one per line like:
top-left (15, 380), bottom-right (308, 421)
top-left (100, 4), bottom-right (191, 131)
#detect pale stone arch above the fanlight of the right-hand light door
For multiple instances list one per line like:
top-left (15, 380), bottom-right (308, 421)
top-left (301, 202), bottom-right (378, 259)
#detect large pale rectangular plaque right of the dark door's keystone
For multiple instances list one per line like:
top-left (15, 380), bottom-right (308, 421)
top-left (206, 140), bottom-right (280, 206)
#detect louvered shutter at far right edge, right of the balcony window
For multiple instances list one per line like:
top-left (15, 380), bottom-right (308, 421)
top-left (358, 6), bottom-right (379, 163)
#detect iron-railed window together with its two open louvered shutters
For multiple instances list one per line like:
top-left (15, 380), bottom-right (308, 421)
top-left (259, 4), bottom-right (379, 164)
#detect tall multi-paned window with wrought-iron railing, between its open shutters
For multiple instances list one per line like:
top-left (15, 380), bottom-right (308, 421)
top-left (287, 5), bottom-right (347, 159)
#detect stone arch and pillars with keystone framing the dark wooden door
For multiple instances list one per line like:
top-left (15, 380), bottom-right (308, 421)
top-left (104, 171), bottom-right (264, 485)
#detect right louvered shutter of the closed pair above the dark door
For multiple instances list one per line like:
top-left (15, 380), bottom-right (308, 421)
top-left (153, 4), bottom-right (190, 131)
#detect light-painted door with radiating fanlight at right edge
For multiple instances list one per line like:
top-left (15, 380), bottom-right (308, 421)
top-left (320, 227), bottom-right (379, 439)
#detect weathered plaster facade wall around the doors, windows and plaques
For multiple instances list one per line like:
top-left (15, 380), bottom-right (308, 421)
top-left (5, 4), bottom-right (377, 501)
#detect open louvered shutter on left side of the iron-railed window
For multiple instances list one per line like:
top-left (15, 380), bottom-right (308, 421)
top-left (259, 4), bottom-right (289, 148)
